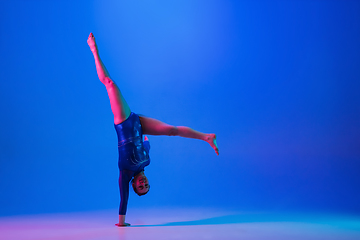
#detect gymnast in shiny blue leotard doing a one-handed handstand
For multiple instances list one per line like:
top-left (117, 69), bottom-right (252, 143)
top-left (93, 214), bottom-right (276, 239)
top-left (87, 33), bottom-right (219, 227)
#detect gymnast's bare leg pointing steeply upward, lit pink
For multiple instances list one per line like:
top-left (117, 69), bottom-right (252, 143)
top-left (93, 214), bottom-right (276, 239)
top-left (87, 33), bottom-right (131, 124)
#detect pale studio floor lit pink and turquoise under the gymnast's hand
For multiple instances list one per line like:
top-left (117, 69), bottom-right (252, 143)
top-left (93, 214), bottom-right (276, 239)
top-left (0, 208), bottom-right (360, 240)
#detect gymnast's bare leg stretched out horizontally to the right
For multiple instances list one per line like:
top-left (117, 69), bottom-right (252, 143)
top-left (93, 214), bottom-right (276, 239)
top-left (140, 116), bottom-right (219, 155)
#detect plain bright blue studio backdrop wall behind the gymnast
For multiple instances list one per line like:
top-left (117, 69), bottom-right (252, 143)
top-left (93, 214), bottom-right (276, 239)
top-left (0, 0), bottom-right (360, 215)
